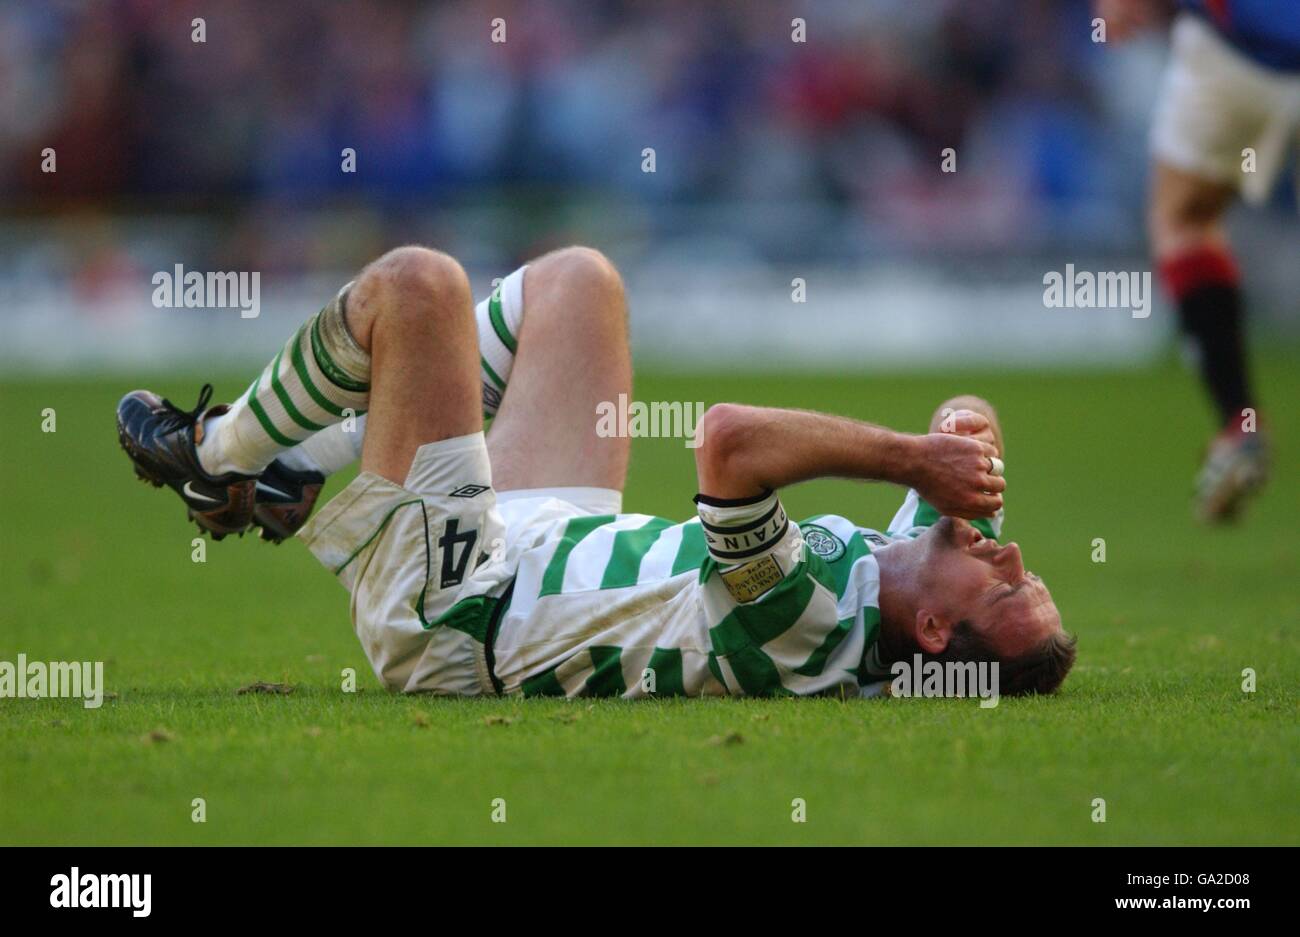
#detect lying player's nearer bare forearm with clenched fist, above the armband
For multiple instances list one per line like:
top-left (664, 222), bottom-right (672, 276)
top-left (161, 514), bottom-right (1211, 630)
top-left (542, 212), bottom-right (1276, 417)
top-left (696, 404), bottom-right (1006, 519)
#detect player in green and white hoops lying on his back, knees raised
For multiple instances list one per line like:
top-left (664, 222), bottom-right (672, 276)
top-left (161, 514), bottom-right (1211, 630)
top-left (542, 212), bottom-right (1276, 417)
top-left (117, 247), bottom-right (1074, 698)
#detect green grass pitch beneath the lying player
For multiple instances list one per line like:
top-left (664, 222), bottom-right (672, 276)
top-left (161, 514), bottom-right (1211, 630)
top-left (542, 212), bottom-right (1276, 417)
top-left (0, 352), bottom-right (1300, 843)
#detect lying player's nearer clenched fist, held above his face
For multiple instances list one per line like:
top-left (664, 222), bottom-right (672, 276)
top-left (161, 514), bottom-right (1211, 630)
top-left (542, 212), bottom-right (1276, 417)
top-left (911, 431), bottom-right (1006, 520)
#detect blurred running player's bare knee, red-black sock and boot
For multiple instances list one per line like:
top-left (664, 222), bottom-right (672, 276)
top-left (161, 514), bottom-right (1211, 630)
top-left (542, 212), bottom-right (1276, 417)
top-left (1151, 160), bottom-right (1268, 521)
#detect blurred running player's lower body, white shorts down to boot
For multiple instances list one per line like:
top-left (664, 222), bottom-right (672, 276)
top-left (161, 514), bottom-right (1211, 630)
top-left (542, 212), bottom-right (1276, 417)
top-left (1148, 4), bottom-right (1300, 522)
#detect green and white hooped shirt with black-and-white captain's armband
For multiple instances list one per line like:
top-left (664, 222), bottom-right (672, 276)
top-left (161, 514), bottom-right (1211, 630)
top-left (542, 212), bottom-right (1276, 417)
top-left (460, 491), bottom-right (1001, 698)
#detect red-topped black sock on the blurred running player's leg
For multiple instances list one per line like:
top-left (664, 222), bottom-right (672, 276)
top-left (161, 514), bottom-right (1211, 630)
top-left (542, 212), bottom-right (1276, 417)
top-left (1160, 247), bottom-right (1251, 425)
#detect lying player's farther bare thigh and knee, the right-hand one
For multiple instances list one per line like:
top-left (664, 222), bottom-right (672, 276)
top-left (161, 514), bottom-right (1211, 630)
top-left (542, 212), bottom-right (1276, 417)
top-left (488, 248), bottom-right (632, 491)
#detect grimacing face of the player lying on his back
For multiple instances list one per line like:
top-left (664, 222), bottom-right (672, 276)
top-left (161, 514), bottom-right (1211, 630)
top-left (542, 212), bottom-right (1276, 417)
top-left (927, 517), bottom-right (1061, 658)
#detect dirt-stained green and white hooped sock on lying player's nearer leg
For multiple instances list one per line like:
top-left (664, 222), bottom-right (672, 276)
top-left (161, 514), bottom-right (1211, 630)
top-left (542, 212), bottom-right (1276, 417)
top-left (198, 283), bottom-right (371, 474)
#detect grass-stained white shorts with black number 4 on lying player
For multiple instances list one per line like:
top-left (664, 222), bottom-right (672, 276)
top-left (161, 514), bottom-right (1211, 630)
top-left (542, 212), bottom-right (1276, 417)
top-left (298, 433), bottom-right (623, 695)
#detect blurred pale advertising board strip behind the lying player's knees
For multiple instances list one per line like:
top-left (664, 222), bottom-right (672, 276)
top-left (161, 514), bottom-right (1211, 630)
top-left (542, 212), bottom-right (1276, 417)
top-left (0, 264), bottom-right (1170, 373)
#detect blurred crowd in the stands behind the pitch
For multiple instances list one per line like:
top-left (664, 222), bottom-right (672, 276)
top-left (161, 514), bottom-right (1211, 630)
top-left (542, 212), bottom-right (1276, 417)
top-left (0, 0), bottom-right (1295, 371)
